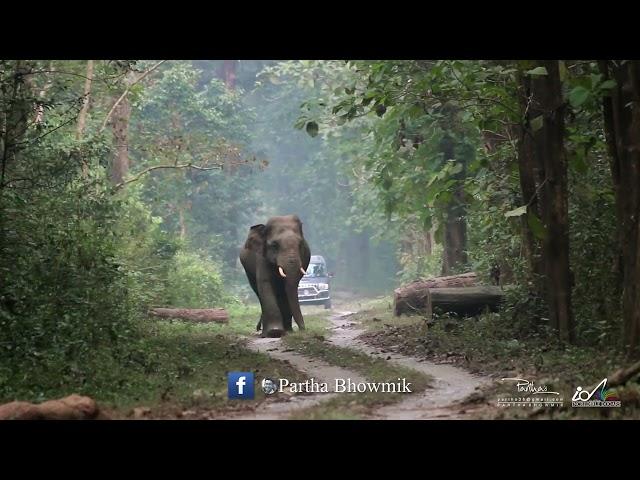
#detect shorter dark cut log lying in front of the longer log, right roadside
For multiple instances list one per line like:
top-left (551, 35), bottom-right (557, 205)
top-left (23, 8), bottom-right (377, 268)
top-left (427, 286), bottom-right (504, 318)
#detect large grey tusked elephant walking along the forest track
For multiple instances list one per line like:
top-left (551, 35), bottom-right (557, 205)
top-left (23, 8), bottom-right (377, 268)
top-left (240, 215), bottom-right (311, 337)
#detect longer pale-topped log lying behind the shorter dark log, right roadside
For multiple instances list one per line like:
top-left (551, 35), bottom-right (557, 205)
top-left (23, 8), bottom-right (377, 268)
top-left (393, 272), bottom-right (478, 317)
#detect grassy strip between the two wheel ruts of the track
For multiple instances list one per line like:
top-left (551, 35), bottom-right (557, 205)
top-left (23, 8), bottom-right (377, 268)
top-left (284, 332), bottom-right (431, 420)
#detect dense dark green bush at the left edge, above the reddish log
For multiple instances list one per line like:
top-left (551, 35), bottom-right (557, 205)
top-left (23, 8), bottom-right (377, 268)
top-left (0, 174), bottom-right (141, 397)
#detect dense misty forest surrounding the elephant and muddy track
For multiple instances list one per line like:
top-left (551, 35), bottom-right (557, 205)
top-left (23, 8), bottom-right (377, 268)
top-left (0, 60), bottom-right (640, 418)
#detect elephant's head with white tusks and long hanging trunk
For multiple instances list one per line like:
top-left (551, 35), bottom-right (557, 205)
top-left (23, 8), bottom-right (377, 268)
top-left (263, 215), bottom-right (310, 329)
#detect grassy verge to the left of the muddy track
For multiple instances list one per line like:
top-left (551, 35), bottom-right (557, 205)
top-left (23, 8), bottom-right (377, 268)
top-left (0, 309), bottom-right (306, 418)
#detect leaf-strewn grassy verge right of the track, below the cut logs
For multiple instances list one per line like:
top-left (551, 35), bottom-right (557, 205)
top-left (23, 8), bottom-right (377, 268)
top-left (354, 299), bottom-right (640, 418)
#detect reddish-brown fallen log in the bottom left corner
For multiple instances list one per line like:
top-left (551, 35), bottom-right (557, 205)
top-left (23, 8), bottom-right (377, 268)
top-left (0, 394), bottom-right (108, 420)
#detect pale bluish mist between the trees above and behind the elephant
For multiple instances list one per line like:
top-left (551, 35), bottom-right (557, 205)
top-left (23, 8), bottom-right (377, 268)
top-left (226, 61), bottom-right (398, 292)
